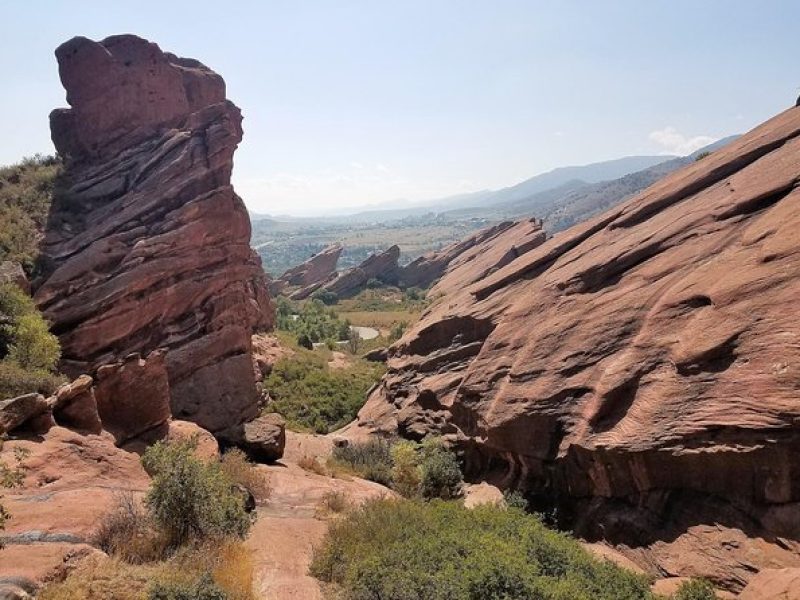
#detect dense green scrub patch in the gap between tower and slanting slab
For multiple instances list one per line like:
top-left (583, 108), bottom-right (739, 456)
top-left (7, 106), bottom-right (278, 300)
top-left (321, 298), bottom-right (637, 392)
top-left (264, 350), bottom-right (383, 433)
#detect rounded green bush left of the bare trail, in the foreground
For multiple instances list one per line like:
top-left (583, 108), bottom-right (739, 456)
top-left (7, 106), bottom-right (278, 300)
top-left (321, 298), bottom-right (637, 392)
top-left (142, 441), bottom-right (250, 546)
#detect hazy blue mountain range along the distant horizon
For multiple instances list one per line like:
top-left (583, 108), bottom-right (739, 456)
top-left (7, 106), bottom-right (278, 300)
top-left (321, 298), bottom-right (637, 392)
top-left (250, 136), bottom-right (738, 232)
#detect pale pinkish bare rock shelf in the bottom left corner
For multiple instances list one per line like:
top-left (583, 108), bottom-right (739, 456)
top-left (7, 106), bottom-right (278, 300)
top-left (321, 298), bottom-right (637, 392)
top-left (0, 427), bottom-right (150, 590)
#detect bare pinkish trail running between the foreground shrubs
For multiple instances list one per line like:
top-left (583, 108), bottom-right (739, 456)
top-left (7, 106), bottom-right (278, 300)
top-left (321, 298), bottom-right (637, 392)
top-left (247, 432), bottom-right (392, 600)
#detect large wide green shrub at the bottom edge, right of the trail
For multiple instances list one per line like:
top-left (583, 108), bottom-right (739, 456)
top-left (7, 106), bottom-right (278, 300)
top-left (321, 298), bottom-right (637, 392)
top-left (311, 499), bottom-right (652, 600)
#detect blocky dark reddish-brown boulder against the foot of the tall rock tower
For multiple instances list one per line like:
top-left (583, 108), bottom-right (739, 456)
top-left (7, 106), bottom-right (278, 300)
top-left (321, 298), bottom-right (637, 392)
top-left (95, 351), bottom-right (172, 445)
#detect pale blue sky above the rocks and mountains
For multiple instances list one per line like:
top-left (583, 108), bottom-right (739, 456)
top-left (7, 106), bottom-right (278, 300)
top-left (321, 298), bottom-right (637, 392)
top-left (0, 0), bottom-right (800, 214)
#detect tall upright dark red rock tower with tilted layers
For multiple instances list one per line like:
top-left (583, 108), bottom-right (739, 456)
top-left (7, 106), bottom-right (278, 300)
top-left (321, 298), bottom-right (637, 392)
top-left (34, 35), bottom-right (272, 437)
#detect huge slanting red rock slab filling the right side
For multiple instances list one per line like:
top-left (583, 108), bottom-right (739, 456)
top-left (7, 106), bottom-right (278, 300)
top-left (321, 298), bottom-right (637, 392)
top-left (348, 109), bottom-right (800, 591)
